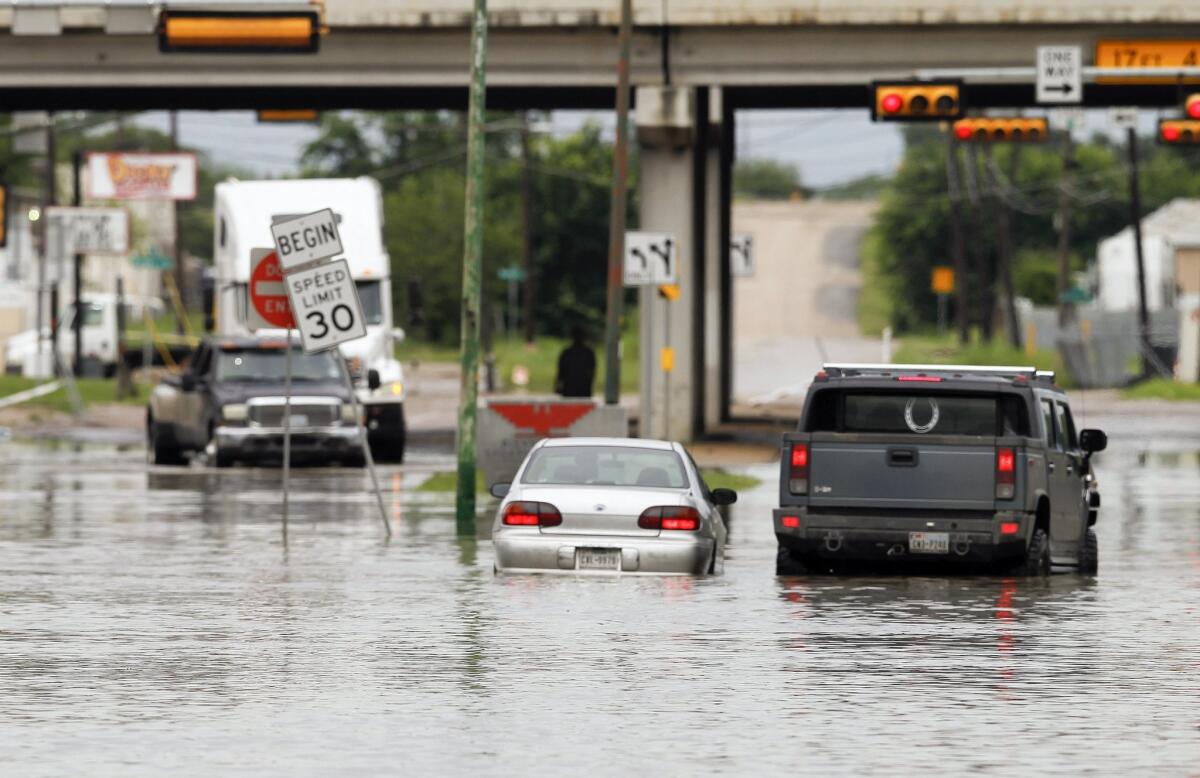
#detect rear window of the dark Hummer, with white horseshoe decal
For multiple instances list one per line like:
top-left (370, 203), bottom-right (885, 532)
top-left (806, 390), bottom-right (1030, 437)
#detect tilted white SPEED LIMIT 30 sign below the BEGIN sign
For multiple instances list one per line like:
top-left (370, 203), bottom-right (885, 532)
top-left (287, 259), bottom-right (367, 354)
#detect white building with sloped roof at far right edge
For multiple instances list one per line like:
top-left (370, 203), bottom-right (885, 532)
top-left (1096, 199), bottom-right (1200, 311)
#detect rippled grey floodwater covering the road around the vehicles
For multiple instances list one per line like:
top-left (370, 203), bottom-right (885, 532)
top-left (0, 410), bottom-right (1200, 777)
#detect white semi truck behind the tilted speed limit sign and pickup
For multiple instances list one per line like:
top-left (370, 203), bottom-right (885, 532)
top-left (212, 176), bottom-right (406, 461)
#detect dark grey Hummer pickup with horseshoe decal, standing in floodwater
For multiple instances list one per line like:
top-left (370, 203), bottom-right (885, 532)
top-left (774, 365), bottom-right (1108, 575)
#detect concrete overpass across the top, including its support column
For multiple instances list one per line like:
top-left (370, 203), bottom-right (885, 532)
top-left (9, 0), bottom-right (1200, 438)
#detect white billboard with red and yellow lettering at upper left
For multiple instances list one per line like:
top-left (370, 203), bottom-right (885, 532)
top-left (88, 151), bottom-right (197, 201)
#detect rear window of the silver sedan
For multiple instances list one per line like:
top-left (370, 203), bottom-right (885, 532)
top-left (521, 445), bottom-right (688, 489)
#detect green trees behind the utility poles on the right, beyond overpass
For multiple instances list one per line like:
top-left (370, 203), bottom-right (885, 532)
top-left (860, 126), bottom-right (1200, 331)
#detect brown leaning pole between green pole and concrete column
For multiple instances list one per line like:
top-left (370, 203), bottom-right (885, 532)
top-left (604, 0), bottom-right (634, 405)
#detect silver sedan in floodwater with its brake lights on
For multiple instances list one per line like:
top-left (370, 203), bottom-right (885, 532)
top-left (492, 438), bottom-right (738, 575)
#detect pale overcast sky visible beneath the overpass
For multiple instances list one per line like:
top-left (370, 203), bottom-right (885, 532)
top-left (137, 110), bottom-right (1171, 188)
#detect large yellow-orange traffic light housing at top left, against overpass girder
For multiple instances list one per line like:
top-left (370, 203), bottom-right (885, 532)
top-left (158, 8), bottom-right (322, 54)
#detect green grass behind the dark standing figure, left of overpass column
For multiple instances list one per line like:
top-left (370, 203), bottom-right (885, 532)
top-left (396, 322), bottom-right (640, 394)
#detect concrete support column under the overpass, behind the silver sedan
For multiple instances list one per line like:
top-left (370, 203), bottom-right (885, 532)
top-left (636, 86), bottom-right (728, 441)
